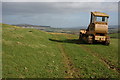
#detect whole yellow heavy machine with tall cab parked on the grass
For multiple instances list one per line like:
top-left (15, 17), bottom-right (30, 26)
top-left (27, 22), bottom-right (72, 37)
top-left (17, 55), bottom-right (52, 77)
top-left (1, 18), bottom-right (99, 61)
top-left (79, 11), bottom-right (110, 45)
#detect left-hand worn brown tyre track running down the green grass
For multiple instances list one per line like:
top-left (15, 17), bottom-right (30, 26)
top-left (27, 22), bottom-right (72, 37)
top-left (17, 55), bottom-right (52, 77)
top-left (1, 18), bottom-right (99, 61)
top-left (55, 36), bottom-right (81, 78)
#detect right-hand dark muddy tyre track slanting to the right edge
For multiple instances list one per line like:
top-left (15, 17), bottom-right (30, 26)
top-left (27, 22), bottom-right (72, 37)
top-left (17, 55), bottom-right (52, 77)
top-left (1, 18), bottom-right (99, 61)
top-left (80, 45), bottom-right (120, 73)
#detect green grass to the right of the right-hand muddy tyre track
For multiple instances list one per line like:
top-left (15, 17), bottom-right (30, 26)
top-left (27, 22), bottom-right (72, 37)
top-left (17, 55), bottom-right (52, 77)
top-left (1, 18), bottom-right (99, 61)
top-left (87, 39), bottom-right (118, 66)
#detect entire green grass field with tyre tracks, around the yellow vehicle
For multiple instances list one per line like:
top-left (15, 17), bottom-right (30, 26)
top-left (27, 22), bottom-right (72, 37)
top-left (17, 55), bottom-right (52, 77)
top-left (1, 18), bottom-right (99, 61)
top-left (2, 24), bottom-right (119, 78)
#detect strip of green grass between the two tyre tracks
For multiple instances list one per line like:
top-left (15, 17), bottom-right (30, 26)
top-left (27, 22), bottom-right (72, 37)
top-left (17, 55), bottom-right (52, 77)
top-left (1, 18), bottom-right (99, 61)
top-left (65, 44), bottom-right (117, 78)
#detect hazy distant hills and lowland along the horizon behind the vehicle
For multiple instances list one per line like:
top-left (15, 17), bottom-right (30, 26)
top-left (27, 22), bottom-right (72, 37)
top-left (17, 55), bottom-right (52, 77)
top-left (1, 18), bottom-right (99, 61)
top-left (13, 24), bottom-right (120, 34)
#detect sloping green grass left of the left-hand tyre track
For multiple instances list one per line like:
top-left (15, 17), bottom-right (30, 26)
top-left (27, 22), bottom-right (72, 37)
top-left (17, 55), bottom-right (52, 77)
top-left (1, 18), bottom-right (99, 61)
top-left (2, 25), bottom-right (66, 78)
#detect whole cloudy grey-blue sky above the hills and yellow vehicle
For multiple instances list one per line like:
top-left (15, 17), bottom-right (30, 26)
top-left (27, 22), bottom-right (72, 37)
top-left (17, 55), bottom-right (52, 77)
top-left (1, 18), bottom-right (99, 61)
top-left (2, 0), bottom-right (118, 28)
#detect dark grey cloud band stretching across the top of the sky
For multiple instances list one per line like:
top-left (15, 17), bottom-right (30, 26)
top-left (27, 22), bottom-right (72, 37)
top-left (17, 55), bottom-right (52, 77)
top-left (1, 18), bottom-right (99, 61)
top-left (2, 2), bottom-right (118, 15)
